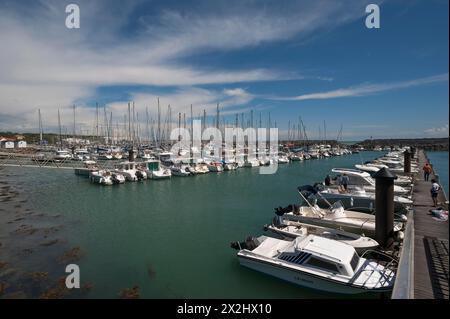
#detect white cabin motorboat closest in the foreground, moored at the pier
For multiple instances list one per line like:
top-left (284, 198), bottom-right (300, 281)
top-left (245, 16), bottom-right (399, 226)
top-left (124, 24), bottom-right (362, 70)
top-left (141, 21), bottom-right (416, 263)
top-left (231, 235), bottom-right (398, 294)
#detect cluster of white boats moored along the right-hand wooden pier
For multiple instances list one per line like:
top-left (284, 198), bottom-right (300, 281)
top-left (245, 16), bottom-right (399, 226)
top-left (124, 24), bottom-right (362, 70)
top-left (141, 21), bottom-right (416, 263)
top-left (231, 150), bottom-right (416, 294)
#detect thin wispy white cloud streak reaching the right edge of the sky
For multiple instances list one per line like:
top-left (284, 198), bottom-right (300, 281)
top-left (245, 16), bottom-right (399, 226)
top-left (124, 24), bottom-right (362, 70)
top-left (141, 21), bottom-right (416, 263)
top-left (270, 73), bottom-right (449, 101)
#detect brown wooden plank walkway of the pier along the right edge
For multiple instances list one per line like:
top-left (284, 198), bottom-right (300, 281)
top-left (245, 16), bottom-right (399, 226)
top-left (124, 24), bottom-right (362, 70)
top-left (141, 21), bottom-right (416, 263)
top-left (413, 150), bottom-right (449, 299)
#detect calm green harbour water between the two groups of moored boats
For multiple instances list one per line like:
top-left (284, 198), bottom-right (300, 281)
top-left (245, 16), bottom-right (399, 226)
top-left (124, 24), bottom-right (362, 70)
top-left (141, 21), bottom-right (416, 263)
top-left (3, 152), bottom-right (381, 298)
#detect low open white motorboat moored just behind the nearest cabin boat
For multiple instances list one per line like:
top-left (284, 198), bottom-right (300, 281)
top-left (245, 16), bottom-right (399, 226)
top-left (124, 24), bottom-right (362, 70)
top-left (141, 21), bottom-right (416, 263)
top-left (264, 216), bottom-right (378, 253)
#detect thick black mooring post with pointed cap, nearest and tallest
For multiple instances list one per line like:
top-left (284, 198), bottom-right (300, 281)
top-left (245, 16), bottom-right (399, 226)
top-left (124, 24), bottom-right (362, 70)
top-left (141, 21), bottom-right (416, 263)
top-left (373, 168), bottom-right (397, 248)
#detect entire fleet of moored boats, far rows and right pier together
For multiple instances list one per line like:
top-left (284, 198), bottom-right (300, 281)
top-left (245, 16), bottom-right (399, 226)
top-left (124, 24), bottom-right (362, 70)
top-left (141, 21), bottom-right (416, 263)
top-left (41, 145), bottom-right (418, 294)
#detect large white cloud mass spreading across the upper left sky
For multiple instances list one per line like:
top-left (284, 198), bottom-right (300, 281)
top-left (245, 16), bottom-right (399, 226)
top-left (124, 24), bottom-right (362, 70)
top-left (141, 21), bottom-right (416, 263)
top-left (0, 0), bottom-right (382, 129)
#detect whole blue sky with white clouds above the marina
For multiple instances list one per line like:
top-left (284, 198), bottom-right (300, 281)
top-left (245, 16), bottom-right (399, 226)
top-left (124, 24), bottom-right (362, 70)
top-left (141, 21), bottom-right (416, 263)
top-left (0, 0), bottom-right (449, 140)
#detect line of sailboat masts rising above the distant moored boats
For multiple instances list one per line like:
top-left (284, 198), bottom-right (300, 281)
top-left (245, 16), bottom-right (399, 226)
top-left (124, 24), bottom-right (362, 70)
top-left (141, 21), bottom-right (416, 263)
top-left (38, 102), bottom-right (343, 147)
